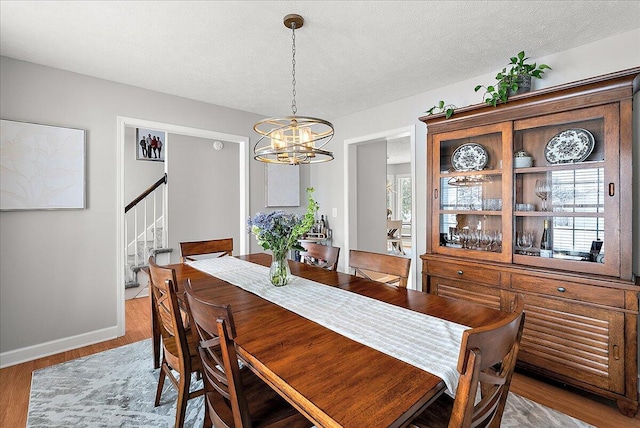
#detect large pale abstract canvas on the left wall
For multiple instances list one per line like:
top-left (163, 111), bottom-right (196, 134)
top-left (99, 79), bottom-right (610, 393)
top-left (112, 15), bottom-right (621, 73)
top-left (0, 119), bottom-right (86, 211)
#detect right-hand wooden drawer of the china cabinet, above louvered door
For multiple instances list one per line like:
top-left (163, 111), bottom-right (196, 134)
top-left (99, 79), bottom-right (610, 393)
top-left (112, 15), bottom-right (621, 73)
top-left (511, 274), bottom-right (624, 308)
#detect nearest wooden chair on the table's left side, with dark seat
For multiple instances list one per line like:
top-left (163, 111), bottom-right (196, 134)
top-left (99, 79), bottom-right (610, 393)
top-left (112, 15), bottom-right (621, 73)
top-left (185, 281), bottom-right (313, 428)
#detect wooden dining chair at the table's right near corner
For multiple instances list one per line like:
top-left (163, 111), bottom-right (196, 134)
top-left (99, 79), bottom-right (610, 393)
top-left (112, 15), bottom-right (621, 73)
top-left (411, 295), bottom-right (525, 428)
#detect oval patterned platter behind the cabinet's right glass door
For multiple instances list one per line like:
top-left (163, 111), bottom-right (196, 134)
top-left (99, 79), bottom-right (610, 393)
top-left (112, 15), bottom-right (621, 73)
top-left (544, 128), bottom-right (595, 164)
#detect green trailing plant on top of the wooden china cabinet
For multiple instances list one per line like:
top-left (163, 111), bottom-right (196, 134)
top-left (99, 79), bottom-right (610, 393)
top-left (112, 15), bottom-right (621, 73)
top-left (475, 51), bottom-right (551, 107)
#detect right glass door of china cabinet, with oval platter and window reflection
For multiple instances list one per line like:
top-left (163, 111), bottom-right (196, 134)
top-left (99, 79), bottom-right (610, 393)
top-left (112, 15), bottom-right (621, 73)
top-left (513, 106), bottom-right (620, 275)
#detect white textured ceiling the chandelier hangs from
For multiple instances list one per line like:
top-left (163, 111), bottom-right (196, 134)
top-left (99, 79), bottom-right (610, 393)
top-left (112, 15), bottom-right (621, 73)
top-left (0, 1), bottom-right (640, 120)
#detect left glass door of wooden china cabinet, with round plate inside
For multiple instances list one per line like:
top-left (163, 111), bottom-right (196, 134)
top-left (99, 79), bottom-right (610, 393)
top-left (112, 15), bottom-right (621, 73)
top-left (431, 125), bottom-right (511, 261)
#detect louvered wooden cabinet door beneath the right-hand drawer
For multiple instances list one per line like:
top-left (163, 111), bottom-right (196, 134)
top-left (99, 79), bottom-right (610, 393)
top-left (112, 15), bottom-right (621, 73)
top-left (518, 294), bottom-right (625, 394)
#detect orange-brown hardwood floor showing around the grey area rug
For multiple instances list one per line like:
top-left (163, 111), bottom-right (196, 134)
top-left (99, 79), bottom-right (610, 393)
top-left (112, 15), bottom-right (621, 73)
top-left (0, 298), bottom-right (640, 428)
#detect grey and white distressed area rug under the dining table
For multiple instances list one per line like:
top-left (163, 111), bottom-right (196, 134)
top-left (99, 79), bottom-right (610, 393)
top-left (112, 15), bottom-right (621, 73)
top-left (27, 340), bottom-right (591, 428)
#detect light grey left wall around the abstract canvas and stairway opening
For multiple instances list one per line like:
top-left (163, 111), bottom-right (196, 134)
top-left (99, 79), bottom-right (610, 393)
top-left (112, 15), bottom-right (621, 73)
top-left (0, 57), bottom-right (288, 365)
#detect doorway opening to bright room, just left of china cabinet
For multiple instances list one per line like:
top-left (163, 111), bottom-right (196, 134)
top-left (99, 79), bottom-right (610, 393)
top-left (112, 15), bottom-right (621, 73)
top-left (344, 126), bottom-right (418, 288)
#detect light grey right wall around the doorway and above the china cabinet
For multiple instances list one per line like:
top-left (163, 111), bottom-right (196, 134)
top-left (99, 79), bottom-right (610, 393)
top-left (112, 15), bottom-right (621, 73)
top-left (312, 28), bottom-right (640, 278)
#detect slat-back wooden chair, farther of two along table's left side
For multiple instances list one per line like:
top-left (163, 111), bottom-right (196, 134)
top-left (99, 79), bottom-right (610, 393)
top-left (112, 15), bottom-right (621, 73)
top-left (149, 256), bottom-right (204, 428)
